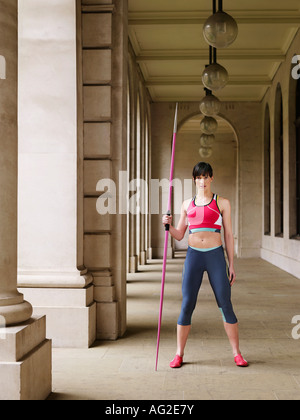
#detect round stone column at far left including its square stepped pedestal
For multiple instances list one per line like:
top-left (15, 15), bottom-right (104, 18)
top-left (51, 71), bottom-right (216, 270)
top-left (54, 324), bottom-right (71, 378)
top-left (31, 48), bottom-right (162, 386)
top-left (0, 0), bottom-right (51, 400)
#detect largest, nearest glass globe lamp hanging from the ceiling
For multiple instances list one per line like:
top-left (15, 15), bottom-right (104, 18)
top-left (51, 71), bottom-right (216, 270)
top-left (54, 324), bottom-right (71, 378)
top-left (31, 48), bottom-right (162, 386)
top-left (203, 10), bottom-right (238, 48)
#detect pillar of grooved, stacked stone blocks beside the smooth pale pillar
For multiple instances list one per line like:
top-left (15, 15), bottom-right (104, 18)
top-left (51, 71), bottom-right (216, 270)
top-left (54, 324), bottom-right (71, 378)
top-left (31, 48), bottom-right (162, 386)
top-left (77, 0), bottom-right (128, 339)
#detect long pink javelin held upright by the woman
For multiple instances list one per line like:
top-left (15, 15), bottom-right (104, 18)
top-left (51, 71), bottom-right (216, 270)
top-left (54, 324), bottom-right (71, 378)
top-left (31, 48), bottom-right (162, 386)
top-left (155, 103), bottom-right (178, 371)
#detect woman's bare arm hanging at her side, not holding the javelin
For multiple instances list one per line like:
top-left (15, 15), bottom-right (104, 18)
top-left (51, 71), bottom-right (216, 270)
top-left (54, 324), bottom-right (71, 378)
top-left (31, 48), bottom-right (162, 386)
top-left (219, 197), bottom-right (236, 285)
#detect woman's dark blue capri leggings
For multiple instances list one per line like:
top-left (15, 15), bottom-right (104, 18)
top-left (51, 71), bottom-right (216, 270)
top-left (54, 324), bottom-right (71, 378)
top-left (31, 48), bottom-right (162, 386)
top-left (178, 246), bottom-right (238, 325)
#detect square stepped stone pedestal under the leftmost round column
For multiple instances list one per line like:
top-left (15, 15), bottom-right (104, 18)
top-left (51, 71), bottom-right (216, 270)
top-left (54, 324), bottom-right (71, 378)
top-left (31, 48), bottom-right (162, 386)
top-left (0, 316), bottom-right (52, 400)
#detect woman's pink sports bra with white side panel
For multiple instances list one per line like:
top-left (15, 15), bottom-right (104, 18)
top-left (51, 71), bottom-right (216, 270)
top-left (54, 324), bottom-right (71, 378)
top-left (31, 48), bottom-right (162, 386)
top-left (187, 194), bottom-right (223, 233)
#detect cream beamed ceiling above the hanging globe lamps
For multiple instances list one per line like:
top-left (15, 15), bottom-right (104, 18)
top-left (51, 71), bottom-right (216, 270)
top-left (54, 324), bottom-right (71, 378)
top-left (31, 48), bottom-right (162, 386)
top-left (129, 0), bottom-right (300, 102)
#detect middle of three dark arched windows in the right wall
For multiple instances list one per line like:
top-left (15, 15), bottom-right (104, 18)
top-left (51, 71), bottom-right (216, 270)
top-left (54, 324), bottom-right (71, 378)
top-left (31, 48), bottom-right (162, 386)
top-left (274, 83), bottom-right (284, 237)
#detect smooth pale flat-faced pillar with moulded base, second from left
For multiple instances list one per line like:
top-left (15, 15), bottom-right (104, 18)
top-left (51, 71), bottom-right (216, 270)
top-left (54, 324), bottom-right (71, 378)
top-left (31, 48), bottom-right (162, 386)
top-left (18, 0), bottom-right (96, 348)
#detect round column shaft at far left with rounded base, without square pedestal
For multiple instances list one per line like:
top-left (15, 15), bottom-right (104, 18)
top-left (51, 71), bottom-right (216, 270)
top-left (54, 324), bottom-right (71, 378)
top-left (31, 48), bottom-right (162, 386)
top-left (0, 0), bottom-right (32, 325)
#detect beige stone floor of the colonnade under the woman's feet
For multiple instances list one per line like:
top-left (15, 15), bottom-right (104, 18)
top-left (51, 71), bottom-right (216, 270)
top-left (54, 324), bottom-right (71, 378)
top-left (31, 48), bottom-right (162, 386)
top-left (49, 259), bottom-right (300, 401)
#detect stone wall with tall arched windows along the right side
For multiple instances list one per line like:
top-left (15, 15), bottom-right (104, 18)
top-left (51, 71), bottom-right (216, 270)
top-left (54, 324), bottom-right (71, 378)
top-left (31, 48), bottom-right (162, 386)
top-left (261, 32), bottom-right (300, 278)
